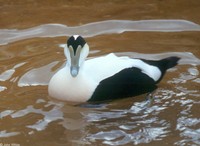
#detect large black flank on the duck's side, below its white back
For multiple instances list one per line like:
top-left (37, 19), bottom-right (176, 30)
top-left (89, 67), bottom-right (157, 102)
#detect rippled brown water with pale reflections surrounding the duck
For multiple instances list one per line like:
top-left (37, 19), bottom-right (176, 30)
top-left (0, 0), bottom-right (200, 146)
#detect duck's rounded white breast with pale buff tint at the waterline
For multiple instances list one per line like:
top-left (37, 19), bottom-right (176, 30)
top-left (48, 66), bottom-right (97, 102)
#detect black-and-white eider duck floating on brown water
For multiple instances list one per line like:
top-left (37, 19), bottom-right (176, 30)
top-left (48, 35), bottom-right (180, 102)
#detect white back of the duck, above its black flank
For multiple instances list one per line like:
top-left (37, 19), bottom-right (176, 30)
top-left (82, 53), bottom-right (161, 83)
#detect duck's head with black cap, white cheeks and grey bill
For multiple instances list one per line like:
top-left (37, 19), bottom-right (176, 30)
top-left (64, 35), bottom-right (89, 78)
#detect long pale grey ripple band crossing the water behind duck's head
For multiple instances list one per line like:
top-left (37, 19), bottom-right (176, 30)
top-left (0, 20), bottom-right (200, 45)
